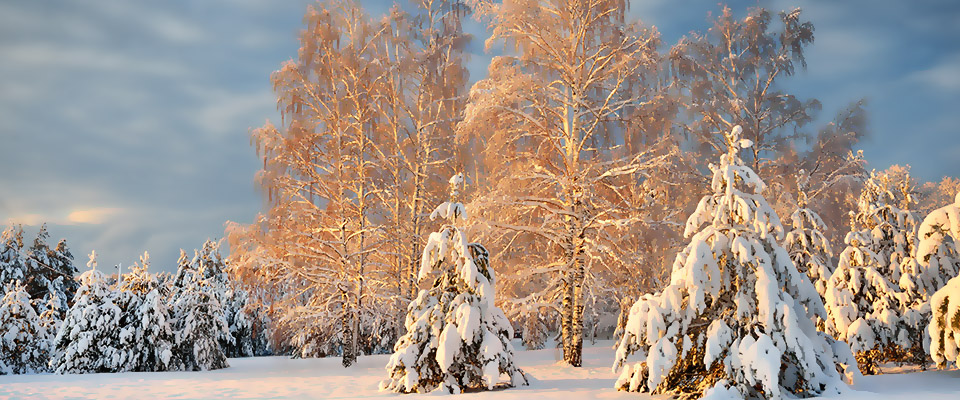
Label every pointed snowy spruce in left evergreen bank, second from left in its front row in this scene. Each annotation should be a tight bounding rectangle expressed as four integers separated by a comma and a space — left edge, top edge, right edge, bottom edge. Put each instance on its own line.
50, 252, 127, 374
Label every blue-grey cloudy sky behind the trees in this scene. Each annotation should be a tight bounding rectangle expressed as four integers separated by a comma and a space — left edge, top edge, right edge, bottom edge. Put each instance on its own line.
0, 0, 960, 271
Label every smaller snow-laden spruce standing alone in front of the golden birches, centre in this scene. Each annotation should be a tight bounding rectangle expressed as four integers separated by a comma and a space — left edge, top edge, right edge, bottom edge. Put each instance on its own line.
380, 174, 527, 393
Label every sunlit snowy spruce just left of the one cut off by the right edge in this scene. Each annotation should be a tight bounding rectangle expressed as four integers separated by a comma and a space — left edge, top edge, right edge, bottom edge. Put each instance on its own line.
824, 169, 929, 374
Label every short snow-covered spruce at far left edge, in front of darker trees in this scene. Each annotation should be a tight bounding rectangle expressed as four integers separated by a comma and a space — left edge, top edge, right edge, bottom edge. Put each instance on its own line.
0, 281, 49, 375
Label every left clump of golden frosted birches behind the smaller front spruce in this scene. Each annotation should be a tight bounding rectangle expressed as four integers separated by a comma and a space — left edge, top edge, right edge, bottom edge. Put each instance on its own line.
228, 0, 469, 366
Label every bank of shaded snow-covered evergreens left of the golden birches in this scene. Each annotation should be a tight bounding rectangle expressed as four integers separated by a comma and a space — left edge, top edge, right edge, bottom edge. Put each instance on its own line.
0, 234, 272, 375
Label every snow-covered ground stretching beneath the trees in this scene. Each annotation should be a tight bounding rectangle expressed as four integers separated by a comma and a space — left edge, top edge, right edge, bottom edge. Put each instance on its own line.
0, 341, 960, 400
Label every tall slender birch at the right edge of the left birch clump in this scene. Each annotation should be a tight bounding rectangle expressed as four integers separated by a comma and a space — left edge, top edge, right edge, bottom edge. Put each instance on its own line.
376, 0, 471, 335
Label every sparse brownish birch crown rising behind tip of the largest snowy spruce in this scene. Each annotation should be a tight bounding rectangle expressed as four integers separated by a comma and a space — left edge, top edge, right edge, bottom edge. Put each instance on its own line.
670, 7, 820, 175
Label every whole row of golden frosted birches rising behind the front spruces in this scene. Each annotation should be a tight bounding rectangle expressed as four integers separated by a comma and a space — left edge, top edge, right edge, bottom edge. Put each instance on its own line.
227, 0, 960, 372
